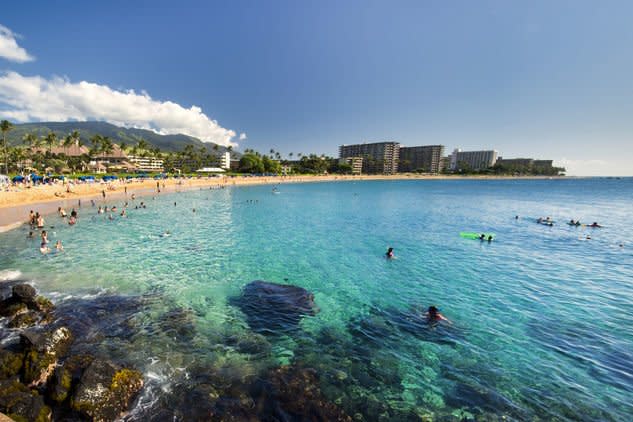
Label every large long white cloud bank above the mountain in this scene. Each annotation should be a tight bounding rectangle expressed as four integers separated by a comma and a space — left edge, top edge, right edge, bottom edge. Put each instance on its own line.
0, 72, 246, 146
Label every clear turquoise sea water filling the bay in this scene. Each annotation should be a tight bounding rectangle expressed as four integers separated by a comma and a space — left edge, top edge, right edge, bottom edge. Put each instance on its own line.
0, 179, 633, 421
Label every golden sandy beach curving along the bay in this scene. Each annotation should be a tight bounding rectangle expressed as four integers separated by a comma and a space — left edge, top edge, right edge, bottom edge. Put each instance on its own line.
0, 174, 571, 233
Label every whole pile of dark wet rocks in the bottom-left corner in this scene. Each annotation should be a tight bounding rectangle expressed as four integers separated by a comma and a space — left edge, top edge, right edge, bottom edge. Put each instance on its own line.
0, 283, 143, 422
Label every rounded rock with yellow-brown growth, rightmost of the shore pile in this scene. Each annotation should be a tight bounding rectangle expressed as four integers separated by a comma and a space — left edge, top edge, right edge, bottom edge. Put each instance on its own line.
70, 360, 143, 421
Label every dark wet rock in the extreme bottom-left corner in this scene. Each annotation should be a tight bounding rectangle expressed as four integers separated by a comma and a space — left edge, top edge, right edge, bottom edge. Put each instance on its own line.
0, 380, 52, 422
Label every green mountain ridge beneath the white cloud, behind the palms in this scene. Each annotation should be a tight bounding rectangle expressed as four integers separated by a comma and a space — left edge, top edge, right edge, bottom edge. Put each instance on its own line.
7, 122, 237, 156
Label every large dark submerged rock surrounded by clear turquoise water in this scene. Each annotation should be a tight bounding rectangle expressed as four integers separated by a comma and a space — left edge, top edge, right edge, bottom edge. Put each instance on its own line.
231, 280, 318, 334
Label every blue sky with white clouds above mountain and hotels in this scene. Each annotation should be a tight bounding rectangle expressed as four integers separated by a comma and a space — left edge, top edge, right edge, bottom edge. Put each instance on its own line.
0, 0, 633, 176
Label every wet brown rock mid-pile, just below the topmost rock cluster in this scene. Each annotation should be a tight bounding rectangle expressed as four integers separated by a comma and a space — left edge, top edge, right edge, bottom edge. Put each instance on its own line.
20, 327, 73, 386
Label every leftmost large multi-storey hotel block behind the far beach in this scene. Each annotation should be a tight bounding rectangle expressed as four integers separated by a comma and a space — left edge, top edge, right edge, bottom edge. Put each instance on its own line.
339, 141, 400, 174
